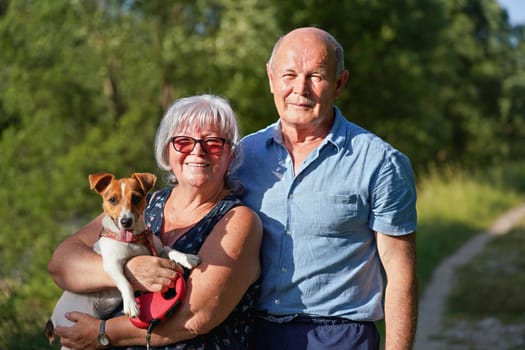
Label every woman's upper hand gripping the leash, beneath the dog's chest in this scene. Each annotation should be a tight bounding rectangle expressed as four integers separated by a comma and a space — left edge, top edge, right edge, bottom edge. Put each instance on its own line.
124, 255, 183, 292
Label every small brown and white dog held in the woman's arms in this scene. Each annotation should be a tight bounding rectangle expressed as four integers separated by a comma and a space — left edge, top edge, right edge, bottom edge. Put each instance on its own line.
45, 173, 200, 342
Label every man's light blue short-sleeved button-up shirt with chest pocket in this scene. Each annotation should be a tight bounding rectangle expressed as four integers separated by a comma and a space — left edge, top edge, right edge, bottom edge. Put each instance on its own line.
235, 107, 416, 321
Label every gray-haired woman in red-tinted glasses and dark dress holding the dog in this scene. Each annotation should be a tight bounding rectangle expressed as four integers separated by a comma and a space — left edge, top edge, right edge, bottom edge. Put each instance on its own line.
48, 95, 262, 349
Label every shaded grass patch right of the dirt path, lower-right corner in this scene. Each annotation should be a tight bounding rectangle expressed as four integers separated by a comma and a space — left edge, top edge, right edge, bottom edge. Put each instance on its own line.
439, 222, 525, 350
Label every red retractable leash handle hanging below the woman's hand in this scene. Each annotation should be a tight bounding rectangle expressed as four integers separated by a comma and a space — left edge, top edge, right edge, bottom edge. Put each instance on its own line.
129, 274, 186, 350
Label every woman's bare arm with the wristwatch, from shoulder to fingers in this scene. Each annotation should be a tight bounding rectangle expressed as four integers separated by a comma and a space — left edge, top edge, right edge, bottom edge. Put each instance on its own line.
57, 207, 262, 349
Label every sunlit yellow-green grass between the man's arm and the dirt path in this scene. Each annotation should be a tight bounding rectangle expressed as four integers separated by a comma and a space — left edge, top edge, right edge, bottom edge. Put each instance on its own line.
417, 165, 525, 291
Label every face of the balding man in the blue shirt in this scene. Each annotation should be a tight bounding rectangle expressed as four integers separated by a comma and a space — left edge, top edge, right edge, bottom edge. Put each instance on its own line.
267, 34, 346, 126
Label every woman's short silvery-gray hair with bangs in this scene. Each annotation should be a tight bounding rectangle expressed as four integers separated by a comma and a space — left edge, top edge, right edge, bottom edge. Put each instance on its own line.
151, 94, 241, 187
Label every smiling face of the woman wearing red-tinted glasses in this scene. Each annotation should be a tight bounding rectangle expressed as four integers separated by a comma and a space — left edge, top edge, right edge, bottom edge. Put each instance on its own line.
167, 127, 232, 187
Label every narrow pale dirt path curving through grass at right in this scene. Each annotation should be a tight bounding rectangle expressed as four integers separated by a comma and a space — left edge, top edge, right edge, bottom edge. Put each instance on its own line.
414, 205, 525, 350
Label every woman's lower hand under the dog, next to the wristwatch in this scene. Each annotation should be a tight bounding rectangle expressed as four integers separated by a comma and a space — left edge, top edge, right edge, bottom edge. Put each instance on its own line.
55, 311, 102, 350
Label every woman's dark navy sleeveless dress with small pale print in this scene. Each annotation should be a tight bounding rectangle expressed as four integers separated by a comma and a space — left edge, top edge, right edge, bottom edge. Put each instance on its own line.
119, 187, 258, 350
